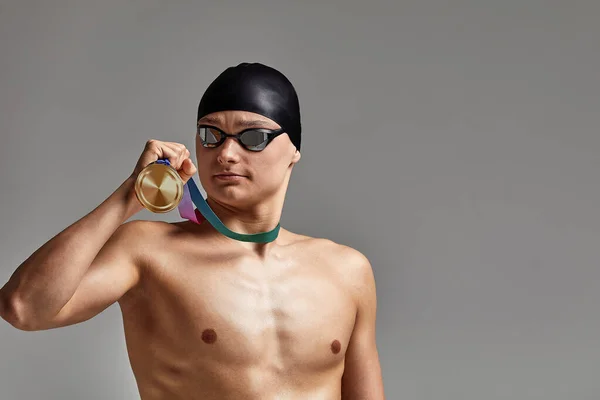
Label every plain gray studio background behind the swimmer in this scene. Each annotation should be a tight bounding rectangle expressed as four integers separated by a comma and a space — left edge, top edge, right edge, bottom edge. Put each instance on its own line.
0, 0, 600, 400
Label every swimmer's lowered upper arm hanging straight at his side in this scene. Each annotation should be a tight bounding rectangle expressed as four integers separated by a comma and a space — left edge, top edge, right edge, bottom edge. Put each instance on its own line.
342, 253, 385, 400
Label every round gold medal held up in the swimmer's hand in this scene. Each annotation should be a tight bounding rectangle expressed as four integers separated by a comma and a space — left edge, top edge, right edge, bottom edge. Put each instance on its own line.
135, 162, 183, 213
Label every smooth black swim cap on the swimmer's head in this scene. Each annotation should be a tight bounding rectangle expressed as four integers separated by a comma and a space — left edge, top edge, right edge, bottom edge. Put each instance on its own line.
196, 63, 302, 150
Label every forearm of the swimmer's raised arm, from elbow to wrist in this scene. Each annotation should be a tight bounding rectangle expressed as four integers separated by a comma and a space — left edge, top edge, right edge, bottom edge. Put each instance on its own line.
0, 177, 142, 323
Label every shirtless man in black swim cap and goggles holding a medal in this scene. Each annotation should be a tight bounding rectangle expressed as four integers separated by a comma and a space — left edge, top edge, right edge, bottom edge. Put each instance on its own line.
0, 64, 384, 400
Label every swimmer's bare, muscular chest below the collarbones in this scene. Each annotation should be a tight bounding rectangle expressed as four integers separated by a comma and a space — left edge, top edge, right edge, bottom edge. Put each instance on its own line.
125, 250, 356, 371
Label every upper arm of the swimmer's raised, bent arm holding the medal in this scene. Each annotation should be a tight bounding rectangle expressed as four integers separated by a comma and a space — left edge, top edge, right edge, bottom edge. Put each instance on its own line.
40, 221, 141, 329
